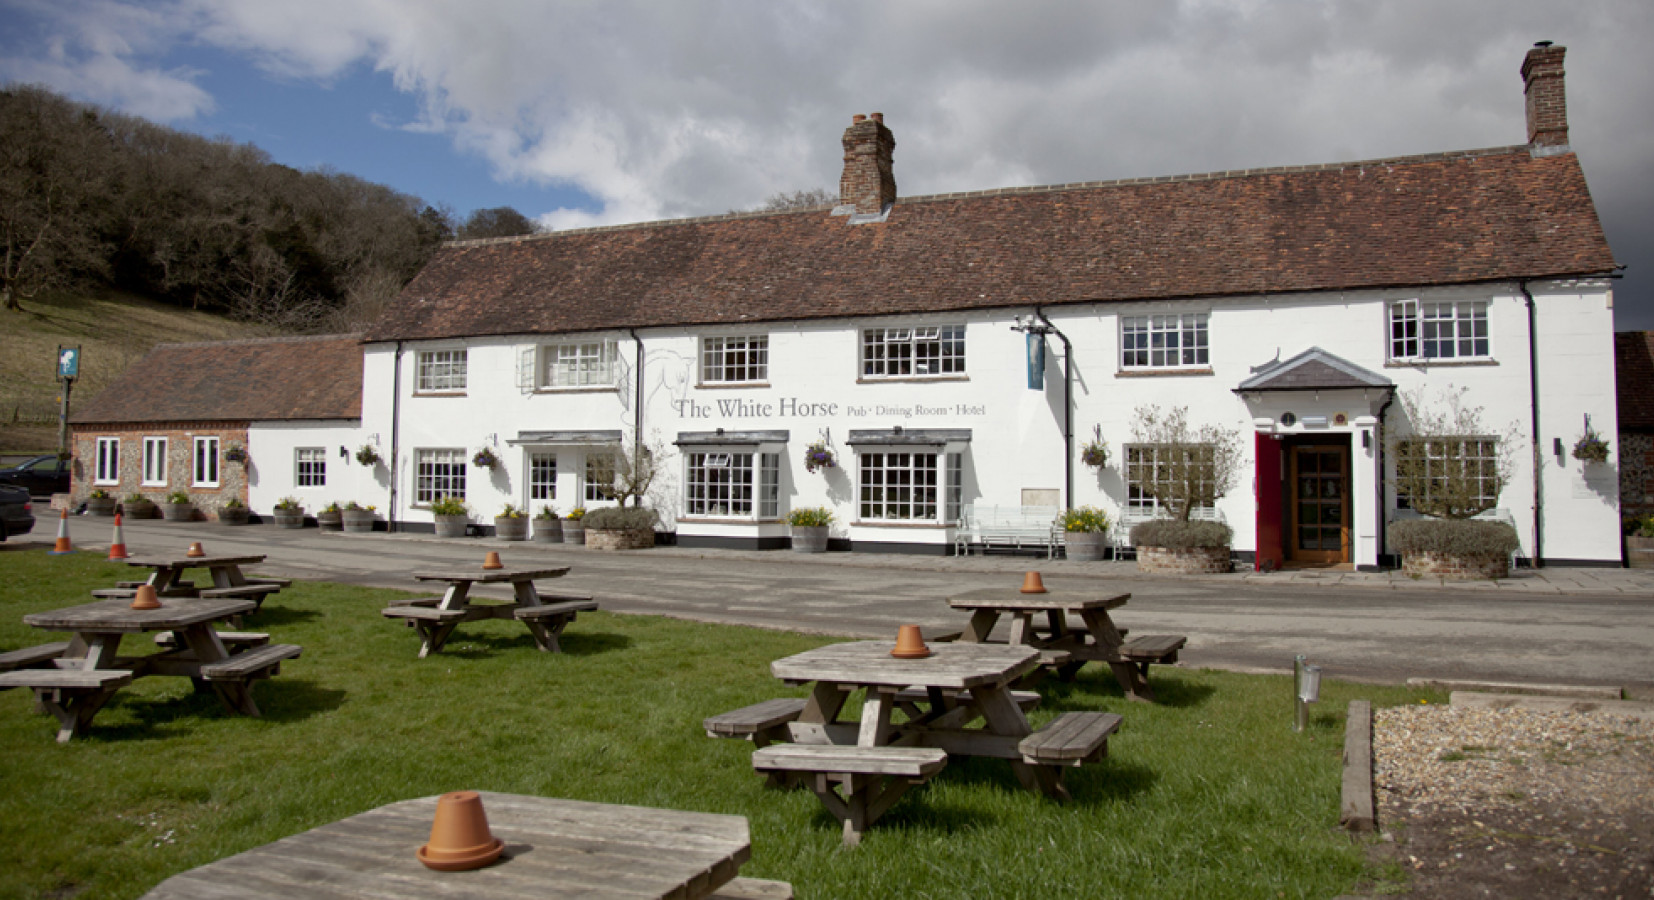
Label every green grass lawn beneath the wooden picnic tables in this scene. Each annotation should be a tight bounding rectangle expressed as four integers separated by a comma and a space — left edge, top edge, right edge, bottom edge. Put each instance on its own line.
0, 549, 1422, 900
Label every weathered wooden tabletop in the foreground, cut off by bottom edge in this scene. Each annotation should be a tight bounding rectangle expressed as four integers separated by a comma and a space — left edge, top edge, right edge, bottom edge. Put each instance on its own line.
144, 792, 792, 900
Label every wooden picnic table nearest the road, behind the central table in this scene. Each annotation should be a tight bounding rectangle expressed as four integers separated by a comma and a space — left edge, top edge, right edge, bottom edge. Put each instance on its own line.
948, 587, 1186, 701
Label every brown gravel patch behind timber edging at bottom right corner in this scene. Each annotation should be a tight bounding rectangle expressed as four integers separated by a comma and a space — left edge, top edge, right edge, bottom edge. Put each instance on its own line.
1373, 705, 1654, 900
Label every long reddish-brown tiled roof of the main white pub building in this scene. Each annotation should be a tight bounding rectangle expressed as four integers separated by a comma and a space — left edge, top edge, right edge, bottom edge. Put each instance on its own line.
367, 147, 1614, 341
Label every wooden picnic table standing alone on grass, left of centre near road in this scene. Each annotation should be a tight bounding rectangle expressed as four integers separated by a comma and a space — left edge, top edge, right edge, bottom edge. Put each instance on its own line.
384, 566, 597, 658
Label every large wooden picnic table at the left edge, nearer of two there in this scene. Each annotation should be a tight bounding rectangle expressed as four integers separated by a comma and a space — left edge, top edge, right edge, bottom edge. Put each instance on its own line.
0, 597, 299, 743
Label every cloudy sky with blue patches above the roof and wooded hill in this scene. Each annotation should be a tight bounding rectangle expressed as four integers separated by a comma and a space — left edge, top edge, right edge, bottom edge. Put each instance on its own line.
0, 0, 1654, 329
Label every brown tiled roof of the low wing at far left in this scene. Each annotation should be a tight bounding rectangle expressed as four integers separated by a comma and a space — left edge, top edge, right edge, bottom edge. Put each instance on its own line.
69, 334, 362, 425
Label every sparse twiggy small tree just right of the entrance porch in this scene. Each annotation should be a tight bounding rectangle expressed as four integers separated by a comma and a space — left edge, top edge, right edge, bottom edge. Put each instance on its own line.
1386, 389, 1522, 519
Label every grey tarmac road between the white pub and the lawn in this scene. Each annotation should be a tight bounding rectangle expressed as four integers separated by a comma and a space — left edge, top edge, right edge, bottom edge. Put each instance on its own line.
32, 511, 1654, 698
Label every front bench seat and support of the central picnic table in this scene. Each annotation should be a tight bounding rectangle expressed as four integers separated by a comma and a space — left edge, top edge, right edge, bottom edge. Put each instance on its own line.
753, 744, 948, 847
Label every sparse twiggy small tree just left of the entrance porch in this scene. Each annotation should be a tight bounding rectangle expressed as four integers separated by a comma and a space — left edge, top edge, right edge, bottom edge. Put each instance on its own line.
1126, 405, 1241, 521
